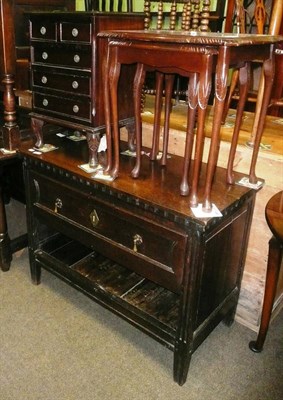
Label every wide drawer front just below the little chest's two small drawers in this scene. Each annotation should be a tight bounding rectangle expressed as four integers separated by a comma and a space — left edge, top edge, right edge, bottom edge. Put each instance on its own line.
32, 43, 92, 71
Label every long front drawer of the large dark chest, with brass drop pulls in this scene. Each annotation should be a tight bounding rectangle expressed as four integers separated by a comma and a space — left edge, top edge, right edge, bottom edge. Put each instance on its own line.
33, 174, 187, 291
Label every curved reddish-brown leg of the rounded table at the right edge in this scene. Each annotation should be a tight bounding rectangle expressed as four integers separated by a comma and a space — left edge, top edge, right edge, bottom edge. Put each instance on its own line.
249, 236, 283, 353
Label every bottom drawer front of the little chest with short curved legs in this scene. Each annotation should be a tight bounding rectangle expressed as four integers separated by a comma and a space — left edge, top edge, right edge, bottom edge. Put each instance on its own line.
33, 92, 92, 122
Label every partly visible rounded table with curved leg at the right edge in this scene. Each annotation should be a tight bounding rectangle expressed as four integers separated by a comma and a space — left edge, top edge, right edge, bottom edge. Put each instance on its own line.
249, 191, 283, 353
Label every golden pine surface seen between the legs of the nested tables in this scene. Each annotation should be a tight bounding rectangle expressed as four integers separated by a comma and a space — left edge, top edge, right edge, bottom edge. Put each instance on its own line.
142, 96, 283, 155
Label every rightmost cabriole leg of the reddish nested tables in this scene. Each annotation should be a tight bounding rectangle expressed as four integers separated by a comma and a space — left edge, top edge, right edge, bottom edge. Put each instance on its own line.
249, 45, 275, 183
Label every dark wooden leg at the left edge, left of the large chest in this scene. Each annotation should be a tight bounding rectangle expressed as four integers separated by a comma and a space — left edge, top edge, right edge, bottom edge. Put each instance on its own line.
0, 181, 12, 271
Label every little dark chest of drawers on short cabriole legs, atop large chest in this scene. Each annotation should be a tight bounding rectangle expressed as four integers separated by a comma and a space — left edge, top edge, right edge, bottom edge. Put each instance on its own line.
30, 12, 143, 165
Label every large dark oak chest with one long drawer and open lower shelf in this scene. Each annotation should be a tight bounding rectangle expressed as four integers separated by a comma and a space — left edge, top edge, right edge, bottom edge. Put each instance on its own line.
20, 137, 255, 385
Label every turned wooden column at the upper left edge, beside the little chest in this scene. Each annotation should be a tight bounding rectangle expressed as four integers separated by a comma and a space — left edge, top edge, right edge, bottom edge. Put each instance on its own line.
0, 0, 20, 150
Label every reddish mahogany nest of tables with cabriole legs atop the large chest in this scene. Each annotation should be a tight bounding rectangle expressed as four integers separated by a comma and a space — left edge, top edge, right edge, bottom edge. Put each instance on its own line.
99, 30, 283, 212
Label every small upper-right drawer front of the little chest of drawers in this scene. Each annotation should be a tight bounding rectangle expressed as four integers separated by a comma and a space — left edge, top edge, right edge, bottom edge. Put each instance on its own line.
60, 22, 91, 43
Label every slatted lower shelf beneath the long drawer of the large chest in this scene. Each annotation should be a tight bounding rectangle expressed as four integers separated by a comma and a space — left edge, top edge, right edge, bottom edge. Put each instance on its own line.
35, 233, 180, 349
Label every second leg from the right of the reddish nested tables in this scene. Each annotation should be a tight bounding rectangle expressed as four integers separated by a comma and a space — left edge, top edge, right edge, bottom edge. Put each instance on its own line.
229, 63, 250, 185
